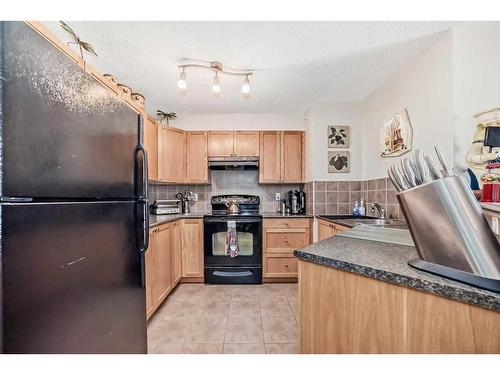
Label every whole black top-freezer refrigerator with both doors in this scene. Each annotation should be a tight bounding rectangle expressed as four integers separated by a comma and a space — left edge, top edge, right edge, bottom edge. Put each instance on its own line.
0, 22, 148, 353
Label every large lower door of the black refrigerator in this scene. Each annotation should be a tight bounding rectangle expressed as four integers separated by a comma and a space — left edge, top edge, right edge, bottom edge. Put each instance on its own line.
1, 202, 146, 353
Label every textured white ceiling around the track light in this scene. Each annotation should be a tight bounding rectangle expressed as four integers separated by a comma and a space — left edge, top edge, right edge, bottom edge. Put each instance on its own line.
45, 21, 451, 113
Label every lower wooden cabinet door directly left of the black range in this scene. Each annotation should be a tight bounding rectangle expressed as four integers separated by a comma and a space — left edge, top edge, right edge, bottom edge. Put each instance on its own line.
182, 219, 204, 279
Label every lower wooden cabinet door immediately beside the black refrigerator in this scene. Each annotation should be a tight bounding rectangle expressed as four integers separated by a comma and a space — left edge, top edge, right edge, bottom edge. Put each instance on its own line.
153, 223, 172, 306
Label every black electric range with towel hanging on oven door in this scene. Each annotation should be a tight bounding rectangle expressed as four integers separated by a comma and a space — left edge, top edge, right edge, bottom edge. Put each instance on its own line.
203, 195, 262, 284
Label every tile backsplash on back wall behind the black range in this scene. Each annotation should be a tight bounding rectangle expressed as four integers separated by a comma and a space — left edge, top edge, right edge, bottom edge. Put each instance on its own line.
149, 170, 304, 212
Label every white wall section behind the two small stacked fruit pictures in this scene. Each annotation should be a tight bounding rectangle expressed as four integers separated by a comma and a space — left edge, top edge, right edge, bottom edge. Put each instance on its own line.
306, 102, 363, 181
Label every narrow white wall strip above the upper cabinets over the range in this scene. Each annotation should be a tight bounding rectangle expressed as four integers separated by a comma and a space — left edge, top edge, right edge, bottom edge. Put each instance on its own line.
172, 113, 305, 130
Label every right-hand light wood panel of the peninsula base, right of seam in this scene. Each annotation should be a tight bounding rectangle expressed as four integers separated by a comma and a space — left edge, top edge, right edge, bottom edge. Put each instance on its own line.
408, 290, 500, 354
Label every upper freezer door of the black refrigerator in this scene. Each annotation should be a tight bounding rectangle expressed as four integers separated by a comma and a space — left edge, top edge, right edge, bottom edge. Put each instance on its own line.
0, 22, 147, 199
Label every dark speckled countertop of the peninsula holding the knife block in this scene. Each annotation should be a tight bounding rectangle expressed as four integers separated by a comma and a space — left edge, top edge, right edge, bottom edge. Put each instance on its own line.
294, 234, 500, 312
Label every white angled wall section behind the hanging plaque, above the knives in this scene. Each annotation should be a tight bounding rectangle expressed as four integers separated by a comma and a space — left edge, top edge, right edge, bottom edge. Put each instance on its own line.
362, 32, 454, 179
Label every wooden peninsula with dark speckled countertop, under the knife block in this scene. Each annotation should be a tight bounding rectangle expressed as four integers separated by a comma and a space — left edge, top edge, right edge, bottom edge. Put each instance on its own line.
294, 234, 500, 354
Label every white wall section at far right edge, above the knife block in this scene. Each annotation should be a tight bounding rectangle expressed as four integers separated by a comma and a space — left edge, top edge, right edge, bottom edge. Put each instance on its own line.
453, 22, 500, 175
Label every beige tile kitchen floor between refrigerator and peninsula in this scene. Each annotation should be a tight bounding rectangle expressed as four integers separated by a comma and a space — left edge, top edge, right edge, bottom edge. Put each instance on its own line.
148, 284, 298, 354
